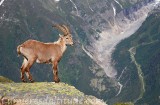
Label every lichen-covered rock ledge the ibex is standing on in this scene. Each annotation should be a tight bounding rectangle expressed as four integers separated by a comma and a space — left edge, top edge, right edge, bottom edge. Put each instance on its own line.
0, 82, 106, 105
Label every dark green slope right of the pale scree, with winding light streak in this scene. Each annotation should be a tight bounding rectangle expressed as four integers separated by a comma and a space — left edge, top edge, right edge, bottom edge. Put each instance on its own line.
113, 6, 160, 105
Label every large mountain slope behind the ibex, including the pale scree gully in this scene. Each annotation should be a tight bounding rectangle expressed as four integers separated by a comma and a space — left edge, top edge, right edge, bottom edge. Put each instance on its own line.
0, 0, 160, 104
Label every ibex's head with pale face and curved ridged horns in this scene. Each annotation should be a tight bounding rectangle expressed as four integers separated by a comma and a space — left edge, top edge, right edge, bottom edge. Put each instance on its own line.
53, 24, 73, 45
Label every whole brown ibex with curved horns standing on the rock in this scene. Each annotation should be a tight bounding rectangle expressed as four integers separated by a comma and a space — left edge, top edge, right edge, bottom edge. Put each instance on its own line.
17, 24, 73, 83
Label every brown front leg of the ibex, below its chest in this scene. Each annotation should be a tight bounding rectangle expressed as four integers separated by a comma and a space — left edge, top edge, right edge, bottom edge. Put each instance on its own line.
53, 62, 60, 83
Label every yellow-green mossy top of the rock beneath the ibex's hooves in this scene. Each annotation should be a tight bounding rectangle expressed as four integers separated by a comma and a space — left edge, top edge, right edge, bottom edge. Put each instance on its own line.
0, 82, 84, 96
